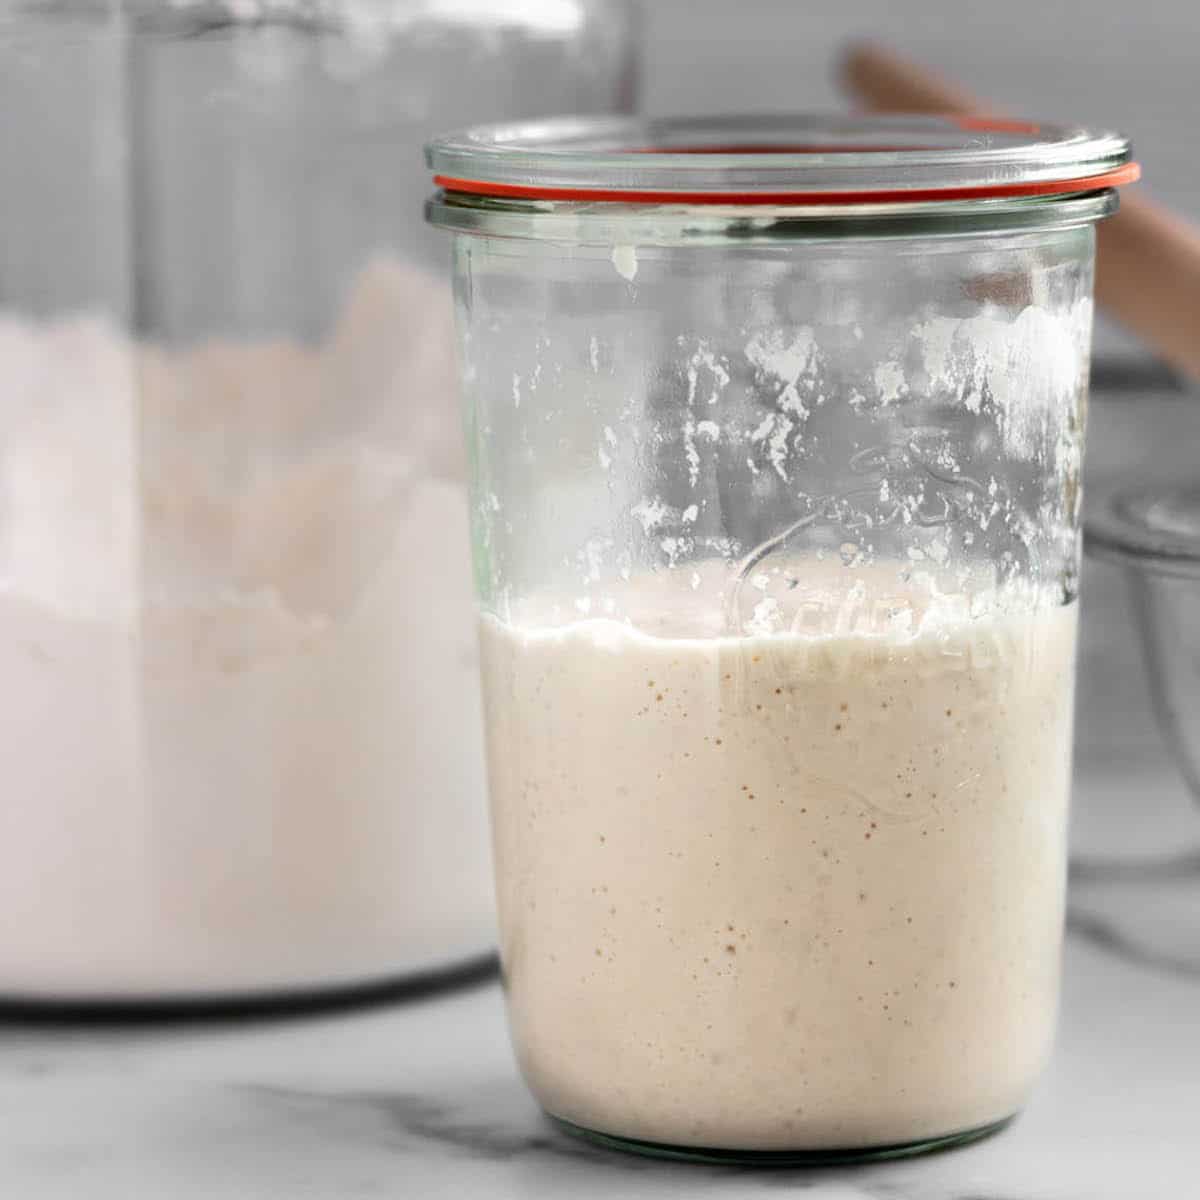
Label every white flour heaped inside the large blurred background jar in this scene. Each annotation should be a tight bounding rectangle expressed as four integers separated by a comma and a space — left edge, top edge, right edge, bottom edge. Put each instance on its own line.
0, 260, 491, 997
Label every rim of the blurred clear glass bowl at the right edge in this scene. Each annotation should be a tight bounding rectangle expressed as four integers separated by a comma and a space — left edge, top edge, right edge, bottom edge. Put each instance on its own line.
1085, 482, 1200, 577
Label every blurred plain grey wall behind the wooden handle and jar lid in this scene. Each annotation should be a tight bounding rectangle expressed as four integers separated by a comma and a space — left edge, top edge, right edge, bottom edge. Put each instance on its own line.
642, 0, 1200, 359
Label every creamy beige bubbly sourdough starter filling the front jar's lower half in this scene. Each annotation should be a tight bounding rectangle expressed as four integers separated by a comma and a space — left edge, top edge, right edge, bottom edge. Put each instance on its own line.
482, 564, 1075, 1150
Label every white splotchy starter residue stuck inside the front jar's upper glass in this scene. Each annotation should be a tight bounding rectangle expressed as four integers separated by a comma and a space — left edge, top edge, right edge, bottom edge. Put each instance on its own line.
559, 300, 1091, 594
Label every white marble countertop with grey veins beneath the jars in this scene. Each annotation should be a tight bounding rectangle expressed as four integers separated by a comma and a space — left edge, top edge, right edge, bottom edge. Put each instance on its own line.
0, 773, 1200, 1200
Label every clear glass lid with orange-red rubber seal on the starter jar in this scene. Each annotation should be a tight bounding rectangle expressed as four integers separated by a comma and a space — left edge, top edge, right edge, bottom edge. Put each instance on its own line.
426, 115, 1140, 206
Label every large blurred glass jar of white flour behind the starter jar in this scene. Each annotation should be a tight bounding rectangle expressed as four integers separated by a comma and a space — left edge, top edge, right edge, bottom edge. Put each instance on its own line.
0, 0, 634, 1002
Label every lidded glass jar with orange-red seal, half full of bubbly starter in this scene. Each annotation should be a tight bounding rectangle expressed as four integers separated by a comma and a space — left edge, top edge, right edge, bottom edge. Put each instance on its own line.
428, 119, 1136, 1160
